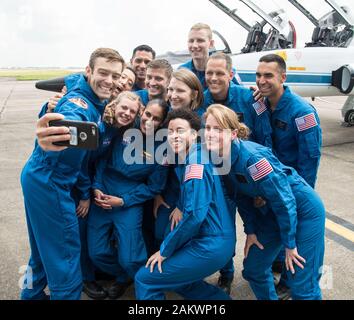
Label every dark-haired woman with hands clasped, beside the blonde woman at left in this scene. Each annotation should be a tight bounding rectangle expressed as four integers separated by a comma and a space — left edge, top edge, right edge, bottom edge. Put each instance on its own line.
88, 100, 168, 298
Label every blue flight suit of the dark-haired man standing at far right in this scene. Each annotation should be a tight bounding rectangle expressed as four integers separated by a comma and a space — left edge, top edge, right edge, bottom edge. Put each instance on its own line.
266, 87, 322, 188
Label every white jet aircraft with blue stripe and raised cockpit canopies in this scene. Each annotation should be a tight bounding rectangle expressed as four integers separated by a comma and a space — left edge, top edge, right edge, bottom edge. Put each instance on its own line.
209, 0, 354, 125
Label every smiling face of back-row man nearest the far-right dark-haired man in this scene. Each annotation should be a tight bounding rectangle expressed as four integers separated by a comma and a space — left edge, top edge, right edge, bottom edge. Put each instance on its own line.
205, 59, 233, 100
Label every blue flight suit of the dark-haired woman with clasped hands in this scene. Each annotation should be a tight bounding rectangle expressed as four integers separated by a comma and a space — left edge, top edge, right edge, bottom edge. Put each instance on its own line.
88, 129, 167, 282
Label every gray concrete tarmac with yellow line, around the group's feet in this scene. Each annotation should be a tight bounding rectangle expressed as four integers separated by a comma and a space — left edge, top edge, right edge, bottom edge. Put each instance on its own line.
0, 78, 354, 300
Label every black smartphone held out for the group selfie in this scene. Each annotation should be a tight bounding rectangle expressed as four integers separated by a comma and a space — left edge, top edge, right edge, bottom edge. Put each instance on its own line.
49, 120, 99, 150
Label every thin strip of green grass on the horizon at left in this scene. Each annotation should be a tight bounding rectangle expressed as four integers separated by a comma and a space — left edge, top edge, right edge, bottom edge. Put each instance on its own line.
0, 69, 83, 81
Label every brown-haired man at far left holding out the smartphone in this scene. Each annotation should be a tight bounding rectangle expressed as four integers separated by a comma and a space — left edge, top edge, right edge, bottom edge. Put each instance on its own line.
21, 48, 124, 300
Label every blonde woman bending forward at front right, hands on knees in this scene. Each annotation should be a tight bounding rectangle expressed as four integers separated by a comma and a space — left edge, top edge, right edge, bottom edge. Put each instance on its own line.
204, 105, 325, 300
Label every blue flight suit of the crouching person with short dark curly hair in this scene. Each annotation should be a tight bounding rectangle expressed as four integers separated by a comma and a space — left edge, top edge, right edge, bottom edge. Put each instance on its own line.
135, 145, 235, 300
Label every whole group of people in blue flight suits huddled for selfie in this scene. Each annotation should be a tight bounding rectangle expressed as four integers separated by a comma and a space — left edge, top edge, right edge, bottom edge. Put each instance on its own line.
21, 20, 325, 299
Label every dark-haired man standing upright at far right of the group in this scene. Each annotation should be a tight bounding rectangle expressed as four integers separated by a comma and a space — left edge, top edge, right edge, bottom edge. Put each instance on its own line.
256, 55, 322, 298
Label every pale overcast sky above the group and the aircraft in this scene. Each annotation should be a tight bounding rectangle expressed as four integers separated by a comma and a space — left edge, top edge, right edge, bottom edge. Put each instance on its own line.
0, 0, 354, 68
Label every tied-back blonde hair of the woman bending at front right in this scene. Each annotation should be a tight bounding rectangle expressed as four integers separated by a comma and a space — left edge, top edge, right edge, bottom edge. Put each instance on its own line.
203, 104, 250, 140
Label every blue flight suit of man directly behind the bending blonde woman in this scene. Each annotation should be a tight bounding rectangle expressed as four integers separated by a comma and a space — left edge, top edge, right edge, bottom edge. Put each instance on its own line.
197, 82, 272, 147
